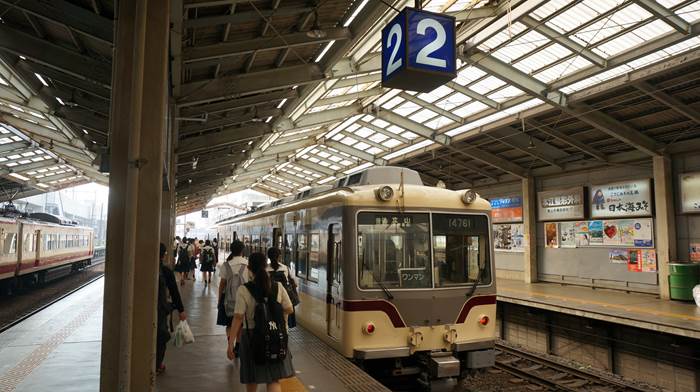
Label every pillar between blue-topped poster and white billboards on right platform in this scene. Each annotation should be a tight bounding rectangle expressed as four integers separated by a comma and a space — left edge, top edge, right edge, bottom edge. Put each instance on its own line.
522, 177, 537, 283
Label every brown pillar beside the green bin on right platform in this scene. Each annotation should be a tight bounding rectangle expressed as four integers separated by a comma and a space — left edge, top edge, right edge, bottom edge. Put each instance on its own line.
653, 156, 677, 299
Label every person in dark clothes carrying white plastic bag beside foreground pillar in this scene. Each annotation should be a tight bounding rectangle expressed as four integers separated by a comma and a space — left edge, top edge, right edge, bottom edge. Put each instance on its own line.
156, 242, 187, 374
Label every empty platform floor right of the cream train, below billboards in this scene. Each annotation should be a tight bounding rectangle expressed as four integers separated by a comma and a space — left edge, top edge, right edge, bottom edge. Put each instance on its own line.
497, 279, 700, 339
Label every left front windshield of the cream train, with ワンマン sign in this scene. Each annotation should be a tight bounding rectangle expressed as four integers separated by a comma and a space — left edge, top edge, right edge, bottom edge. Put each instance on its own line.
357, 212, 433, 289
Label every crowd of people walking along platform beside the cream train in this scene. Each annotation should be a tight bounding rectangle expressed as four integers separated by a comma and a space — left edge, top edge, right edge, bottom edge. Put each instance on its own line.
156, 236, 299, 392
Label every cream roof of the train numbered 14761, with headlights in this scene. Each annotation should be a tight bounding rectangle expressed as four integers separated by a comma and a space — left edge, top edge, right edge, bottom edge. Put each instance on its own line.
217, 166, 491, 225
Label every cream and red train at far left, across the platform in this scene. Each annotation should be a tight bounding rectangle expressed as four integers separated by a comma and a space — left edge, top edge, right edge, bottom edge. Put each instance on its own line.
0, 204, 95, 291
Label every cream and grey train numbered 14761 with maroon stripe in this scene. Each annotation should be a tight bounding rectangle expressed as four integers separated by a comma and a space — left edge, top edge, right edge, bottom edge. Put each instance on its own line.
217, 167, 496, 388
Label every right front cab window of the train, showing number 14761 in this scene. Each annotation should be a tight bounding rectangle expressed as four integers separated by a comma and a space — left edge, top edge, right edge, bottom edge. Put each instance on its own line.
433, 214, 491, 287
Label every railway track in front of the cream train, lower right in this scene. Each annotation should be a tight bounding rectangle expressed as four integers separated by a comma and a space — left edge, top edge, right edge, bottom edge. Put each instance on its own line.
495, 342, 658, 392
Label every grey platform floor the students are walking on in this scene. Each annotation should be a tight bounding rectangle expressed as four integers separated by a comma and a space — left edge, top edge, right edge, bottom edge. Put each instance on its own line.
0, 270, 388, 392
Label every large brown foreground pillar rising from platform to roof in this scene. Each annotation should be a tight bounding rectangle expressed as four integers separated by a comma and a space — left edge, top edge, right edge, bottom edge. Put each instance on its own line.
100, 0, 170, 392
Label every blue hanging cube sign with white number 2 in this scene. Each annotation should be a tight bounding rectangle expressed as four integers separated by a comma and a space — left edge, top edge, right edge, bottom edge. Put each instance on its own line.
382, 7, 456, 92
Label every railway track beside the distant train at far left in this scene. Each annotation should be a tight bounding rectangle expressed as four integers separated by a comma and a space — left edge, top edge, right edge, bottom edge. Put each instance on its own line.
0, 257, 104, 333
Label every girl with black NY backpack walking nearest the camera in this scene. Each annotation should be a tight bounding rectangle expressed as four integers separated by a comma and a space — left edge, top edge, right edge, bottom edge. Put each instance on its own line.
227, 252, 294, 392
